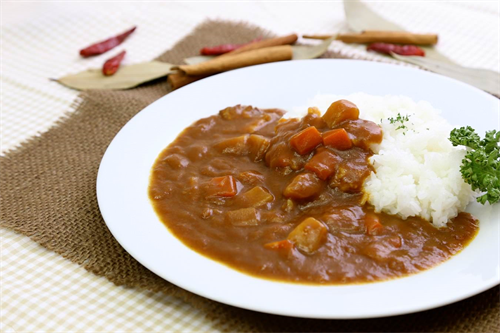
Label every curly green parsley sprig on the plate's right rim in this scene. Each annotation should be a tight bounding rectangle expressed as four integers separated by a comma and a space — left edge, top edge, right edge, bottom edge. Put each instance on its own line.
449, 126, 500, 205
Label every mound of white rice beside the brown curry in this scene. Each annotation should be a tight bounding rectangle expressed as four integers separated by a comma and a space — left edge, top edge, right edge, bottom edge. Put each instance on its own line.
287, 93, 474, 227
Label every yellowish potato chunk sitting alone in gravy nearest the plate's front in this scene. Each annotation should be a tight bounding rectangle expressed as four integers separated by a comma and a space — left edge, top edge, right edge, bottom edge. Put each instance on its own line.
287, 217, 328, 254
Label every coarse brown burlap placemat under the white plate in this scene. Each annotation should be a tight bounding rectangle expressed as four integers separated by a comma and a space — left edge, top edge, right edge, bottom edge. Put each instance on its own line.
0, 21, 500, 332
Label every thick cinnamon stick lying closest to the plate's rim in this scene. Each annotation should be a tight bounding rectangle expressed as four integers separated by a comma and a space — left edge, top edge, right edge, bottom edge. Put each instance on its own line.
176, 45, 293, 76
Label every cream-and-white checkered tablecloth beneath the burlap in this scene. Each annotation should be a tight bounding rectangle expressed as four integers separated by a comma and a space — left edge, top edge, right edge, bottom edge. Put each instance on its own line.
0, 1, 500, 332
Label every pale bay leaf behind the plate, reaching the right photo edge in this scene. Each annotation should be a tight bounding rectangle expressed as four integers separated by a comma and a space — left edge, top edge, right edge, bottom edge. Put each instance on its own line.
391, 53, 500, 96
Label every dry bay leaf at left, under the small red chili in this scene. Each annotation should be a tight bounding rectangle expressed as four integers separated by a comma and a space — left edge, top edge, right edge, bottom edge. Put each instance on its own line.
55, 61, 175, 90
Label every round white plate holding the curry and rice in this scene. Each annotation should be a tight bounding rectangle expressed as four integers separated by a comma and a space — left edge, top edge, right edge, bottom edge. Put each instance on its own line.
97, 59, 500, 319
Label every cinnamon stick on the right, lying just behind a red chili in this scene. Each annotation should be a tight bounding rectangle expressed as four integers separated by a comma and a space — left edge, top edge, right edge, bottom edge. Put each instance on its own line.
303, 30, 438, 45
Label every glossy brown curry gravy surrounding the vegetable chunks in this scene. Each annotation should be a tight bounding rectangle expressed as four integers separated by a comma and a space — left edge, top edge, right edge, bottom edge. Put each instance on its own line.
149, 105, 478, 284
